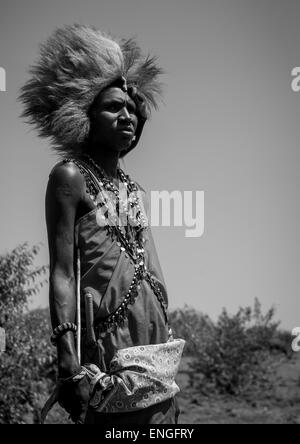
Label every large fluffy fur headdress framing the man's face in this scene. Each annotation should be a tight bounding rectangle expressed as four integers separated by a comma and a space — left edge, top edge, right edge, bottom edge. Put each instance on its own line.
19, 25, 162, 155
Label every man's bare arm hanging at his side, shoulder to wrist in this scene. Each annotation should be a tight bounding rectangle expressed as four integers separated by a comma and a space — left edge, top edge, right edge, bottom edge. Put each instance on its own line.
46, 164, 84, 377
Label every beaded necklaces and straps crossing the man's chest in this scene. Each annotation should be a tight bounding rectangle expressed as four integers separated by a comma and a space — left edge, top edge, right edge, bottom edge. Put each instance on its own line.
64, 156, 169, 334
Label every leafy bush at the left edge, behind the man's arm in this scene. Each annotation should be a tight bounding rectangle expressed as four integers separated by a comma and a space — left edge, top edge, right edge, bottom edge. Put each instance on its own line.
0, 243, 54, 424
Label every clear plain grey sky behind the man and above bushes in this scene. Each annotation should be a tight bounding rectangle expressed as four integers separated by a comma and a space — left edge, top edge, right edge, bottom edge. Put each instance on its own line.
0, 0, 300, 329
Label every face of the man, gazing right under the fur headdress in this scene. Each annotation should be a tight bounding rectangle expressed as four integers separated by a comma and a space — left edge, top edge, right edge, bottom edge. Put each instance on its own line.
90, 87, 138, 152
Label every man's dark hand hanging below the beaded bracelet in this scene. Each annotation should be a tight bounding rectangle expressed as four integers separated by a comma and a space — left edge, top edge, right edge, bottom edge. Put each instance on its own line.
58, 376, 90, 424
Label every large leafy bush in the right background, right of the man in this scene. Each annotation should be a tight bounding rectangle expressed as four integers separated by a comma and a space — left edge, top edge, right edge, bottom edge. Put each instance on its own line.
172, 300, 286, 395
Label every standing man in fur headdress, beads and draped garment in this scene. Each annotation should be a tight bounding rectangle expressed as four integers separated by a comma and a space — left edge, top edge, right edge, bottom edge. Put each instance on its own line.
21, 25, 182, 424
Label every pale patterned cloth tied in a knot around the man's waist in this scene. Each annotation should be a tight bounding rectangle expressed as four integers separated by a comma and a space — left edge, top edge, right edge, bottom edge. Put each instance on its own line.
85, 339, 185, 413
